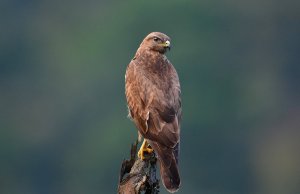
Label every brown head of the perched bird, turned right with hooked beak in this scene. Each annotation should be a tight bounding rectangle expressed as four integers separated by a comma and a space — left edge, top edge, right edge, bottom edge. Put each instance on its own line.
140, 32, 171, 54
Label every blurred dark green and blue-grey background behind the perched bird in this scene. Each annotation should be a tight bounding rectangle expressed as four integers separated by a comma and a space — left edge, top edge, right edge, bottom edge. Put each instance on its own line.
0, 0, 300, 194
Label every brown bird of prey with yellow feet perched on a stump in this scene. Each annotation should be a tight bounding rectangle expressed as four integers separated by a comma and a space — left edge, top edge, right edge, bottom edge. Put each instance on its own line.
125, 32, 181, 193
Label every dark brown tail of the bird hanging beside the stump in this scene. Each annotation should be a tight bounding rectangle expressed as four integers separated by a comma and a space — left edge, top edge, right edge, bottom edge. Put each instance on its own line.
151, 143, 180, 193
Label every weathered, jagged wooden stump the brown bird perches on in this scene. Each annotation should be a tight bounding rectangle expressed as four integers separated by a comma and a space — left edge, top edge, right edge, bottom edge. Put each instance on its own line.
118, 141, 159, 194
